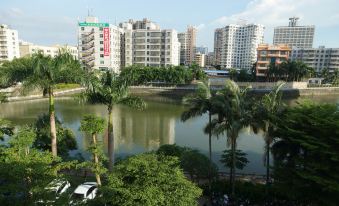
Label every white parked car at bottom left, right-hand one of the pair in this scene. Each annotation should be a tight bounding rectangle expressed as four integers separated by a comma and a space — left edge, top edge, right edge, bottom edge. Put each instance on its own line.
71, 182, 98, 204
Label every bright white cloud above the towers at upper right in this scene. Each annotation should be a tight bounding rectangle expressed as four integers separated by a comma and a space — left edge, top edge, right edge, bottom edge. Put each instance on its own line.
212, 0, 339, 27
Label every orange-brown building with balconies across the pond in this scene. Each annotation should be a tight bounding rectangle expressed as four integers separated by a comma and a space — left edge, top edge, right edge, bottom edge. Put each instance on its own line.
256, 44, 292, 77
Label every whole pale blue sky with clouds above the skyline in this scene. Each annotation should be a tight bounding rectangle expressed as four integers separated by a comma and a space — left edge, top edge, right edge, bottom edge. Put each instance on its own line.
0, 0, 339, 51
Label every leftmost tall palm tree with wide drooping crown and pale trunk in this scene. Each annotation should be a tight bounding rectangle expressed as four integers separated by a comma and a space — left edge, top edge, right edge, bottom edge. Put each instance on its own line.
2, 50, 83, 156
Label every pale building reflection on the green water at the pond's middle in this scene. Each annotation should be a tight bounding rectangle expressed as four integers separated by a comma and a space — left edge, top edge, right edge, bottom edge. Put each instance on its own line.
109, 107, 175, 151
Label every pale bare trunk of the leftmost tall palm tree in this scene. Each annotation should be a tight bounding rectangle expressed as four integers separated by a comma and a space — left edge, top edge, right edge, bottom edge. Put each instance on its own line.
48, 87, 58, 157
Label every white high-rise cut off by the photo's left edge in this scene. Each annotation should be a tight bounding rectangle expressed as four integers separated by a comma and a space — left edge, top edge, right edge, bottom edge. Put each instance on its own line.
0, 24, 20, 61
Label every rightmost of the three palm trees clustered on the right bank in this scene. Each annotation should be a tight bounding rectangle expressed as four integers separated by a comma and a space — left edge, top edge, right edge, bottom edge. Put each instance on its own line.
251, 83, 285, 191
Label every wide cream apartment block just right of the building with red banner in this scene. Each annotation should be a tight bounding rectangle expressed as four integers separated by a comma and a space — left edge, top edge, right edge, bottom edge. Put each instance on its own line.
120, 19, 180, 67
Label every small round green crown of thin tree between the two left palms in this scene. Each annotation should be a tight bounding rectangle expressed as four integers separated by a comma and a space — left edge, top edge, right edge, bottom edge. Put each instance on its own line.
80, 115, 105, 134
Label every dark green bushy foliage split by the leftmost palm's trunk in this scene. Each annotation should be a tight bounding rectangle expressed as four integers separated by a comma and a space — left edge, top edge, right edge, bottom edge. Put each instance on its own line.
33, 114, 77, 159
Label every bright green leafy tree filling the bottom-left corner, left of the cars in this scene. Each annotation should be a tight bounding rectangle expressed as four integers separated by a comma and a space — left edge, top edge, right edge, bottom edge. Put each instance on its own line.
0, 126, 65, 205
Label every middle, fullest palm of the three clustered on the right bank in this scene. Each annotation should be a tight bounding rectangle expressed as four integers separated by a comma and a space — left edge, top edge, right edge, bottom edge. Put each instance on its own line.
209, 80, 250, 196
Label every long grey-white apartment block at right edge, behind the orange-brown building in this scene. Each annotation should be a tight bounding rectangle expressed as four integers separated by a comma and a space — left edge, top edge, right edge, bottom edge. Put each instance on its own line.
291, 46, 339, 72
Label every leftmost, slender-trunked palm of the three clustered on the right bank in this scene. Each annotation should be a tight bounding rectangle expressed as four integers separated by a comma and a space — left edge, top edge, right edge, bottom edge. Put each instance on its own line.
181, 82, 215, 192
